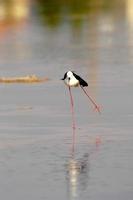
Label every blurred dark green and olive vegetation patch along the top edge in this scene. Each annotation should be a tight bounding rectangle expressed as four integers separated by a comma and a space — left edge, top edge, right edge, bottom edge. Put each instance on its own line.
36, 0, 125, 27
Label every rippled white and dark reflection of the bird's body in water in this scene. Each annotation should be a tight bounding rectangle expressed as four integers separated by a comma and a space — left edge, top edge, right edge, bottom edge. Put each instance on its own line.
66, 135, 99, 200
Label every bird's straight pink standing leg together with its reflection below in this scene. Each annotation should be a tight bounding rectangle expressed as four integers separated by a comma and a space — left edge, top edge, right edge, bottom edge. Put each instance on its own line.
69, 86, 76, 153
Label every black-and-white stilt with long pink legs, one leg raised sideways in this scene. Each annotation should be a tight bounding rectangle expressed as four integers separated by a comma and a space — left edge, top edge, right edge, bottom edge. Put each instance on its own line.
61, 71, 100, 122
